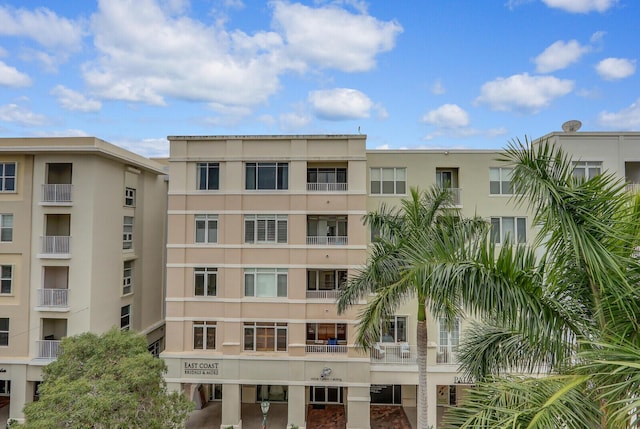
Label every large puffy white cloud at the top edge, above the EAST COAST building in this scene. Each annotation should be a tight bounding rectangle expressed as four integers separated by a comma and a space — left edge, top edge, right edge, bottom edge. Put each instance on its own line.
271, 1, 402, 72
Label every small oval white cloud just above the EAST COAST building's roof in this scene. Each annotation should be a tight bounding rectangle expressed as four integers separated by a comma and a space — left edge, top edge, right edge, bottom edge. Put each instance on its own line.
308, 88, 373, 121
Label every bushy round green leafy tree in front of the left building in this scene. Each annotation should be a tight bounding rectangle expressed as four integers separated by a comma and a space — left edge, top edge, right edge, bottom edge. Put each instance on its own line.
24, 328, 193, 429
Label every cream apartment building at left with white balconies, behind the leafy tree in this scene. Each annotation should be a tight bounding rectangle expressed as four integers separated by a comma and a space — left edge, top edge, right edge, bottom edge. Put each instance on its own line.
0, 137, 167, 420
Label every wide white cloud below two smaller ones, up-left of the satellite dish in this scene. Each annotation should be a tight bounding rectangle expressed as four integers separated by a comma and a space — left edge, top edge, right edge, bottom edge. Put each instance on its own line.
476, 73, 574, 113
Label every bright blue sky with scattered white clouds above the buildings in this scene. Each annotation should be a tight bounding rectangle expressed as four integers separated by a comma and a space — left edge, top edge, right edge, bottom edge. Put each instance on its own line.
0, 0, 640, 157
